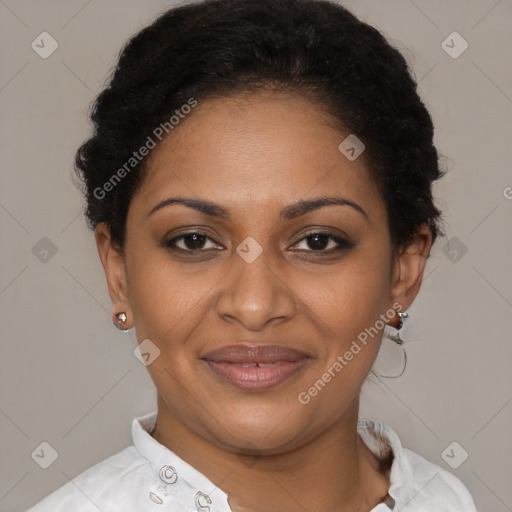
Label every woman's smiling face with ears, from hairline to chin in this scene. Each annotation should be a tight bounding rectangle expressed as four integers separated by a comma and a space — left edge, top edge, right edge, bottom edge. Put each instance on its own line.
97, 93, 429, 453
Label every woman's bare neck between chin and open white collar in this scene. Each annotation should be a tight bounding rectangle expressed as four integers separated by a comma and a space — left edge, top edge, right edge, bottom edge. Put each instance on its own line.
152, 396, 389, 512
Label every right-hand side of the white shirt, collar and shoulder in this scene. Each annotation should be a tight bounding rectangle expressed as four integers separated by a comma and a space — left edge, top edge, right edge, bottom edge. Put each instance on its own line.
358, 418, 476, 512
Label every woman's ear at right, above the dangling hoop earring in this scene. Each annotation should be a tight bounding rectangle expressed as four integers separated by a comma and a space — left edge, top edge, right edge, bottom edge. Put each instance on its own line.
390, 224, 432, 311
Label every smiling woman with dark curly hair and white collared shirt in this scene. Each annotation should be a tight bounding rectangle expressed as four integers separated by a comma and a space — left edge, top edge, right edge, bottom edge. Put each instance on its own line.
27, 0, 475, 512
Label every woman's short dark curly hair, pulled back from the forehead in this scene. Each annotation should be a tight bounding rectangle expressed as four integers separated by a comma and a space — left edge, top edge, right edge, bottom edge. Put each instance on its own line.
75, 0, 443, 249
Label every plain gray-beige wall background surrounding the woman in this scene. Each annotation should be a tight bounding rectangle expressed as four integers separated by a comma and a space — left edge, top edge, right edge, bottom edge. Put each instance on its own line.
0, 0, 512, 512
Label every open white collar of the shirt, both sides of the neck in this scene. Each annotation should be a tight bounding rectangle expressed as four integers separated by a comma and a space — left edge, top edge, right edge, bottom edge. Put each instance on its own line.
132, 411, 412, 512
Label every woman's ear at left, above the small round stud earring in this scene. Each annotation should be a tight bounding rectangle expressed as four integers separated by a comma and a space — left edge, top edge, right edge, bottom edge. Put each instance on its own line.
94, 222, 132, 329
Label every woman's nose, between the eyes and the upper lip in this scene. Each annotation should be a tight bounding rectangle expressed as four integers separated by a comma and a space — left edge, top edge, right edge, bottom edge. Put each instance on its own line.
216, 245, 297, 331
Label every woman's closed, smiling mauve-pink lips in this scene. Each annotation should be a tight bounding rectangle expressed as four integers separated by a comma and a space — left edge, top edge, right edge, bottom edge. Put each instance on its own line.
201, 344, 311, 391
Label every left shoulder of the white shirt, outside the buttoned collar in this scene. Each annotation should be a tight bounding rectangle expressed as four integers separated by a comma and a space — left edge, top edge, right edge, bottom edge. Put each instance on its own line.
27, 445, 152, 512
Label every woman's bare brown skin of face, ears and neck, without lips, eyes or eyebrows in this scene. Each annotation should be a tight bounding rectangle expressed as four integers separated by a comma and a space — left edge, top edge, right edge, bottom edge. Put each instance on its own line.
95, 92, 432, 512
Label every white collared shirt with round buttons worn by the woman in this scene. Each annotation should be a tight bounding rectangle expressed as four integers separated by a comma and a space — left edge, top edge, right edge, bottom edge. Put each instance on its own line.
27, 412, 476, 512
